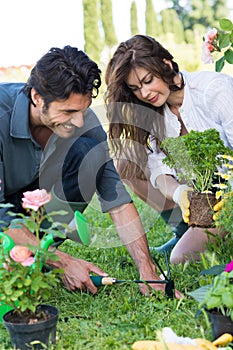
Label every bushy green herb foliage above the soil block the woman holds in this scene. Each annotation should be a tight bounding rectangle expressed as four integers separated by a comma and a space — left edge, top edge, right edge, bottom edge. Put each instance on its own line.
161, 129, 232, 192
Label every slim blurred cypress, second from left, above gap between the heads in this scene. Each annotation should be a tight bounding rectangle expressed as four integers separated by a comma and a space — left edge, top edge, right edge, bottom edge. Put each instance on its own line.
100, 0, 117, 47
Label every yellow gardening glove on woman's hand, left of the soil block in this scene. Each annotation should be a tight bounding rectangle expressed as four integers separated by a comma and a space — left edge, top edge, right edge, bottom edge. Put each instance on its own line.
173, 185, 193, 224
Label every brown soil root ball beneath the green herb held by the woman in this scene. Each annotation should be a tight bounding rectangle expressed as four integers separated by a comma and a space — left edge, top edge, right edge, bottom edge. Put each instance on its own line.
189, 192, 217, 228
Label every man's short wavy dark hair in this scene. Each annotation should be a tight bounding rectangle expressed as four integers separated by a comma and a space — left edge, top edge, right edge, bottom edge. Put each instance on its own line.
23, 46, 101, 108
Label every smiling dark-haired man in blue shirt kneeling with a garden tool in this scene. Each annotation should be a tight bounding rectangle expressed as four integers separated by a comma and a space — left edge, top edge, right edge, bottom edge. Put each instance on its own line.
0, 46, 180, 297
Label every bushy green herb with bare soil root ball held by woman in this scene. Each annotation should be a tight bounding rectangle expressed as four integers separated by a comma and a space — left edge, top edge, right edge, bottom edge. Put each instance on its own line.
161, 129, 232, 227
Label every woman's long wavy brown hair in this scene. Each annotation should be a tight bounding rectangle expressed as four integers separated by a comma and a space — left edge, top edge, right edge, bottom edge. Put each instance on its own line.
105, 35, 183, 178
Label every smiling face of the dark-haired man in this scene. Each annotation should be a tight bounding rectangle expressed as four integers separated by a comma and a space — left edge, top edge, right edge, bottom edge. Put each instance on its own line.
39, 93, 92, 138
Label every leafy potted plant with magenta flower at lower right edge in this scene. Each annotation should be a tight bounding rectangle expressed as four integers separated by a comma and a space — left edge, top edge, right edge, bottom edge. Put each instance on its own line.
189, 260, 233, 338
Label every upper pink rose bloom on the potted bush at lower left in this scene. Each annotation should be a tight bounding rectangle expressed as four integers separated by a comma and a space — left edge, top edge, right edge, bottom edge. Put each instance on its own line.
22, 190, 52, 211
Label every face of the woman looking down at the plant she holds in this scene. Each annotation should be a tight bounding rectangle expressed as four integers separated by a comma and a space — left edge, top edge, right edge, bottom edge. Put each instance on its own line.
126, 67, 170, 107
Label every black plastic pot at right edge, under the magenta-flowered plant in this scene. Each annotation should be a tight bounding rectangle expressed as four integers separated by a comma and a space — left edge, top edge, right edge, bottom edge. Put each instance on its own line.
207, 309, 233, 339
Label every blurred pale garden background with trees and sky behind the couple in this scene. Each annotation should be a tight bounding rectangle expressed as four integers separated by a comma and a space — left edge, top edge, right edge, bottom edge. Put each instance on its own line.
0, 0, 233, 84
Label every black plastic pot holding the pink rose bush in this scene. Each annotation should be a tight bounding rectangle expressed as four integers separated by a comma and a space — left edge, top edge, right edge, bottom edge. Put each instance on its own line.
3, 305, 59, 350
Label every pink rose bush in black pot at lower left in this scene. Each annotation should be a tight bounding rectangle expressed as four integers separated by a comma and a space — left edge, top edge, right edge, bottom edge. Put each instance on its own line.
0, 190, 64, 349
